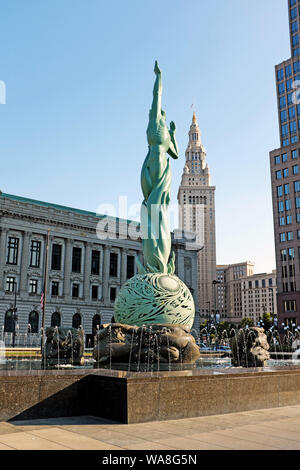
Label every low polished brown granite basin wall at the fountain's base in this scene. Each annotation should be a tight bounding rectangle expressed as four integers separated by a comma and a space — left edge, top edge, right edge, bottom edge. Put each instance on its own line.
0, 365, 300, 423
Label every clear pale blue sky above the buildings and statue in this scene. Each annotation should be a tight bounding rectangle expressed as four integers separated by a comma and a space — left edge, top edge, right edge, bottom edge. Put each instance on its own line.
0, 0, 290, 273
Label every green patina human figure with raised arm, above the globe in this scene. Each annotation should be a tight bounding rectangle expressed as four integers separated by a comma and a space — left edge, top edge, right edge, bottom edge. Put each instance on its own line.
138, 62, 178, 274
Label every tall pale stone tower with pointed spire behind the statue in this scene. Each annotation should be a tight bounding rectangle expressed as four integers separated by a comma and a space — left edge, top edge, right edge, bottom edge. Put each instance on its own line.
177, 113, 216, 318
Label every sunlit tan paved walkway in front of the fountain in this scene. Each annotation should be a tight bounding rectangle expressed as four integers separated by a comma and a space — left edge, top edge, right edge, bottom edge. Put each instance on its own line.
0, 405, 300, 450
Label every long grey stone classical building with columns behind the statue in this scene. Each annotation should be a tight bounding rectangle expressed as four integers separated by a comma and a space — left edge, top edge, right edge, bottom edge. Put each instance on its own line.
0, 189, 199, 339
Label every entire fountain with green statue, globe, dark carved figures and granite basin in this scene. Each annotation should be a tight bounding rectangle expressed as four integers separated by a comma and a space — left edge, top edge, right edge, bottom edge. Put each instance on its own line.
0, 63, 300, 423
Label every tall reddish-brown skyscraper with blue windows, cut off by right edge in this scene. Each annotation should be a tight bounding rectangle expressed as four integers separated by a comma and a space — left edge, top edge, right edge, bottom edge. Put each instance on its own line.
270, 0, 300, 328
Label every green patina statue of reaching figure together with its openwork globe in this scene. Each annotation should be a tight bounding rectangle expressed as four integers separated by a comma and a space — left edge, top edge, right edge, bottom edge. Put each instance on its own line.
115, 62, 195, 328
